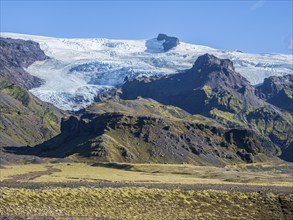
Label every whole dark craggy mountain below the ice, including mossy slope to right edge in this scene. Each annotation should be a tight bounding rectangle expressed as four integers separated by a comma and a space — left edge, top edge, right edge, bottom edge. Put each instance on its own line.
121, 54, 293, 160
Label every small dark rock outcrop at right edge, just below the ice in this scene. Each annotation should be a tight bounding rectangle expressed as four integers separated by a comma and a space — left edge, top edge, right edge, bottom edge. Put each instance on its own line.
256, 74, 293, 113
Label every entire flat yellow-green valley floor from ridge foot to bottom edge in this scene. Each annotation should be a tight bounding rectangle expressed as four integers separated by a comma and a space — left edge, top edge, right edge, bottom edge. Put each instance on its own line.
0, 163, 293, 220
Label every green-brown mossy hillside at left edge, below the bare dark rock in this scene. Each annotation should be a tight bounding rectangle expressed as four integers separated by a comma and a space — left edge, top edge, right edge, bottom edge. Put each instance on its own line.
0, 81, 65, 146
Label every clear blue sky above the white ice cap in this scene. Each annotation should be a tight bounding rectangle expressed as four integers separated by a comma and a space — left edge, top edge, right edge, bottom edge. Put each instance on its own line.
1, 0, 293, 53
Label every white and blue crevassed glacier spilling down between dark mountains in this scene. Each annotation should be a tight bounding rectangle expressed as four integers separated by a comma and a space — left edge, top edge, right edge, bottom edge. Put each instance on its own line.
1, 33, 293, 110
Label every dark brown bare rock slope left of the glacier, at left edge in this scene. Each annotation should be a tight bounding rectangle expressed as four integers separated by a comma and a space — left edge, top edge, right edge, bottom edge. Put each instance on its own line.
0, 37, 48, 89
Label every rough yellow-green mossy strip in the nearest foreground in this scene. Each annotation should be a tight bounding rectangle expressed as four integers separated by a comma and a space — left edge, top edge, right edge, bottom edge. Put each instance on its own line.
0, 188, 293, 220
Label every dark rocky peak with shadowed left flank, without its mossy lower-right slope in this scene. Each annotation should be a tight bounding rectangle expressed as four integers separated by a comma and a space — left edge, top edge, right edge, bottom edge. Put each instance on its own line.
122, 54, 263, 115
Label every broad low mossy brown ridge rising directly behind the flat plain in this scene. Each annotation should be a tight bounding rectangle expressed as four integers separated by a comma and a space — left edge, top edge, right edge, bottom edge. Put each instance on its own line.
6, 99, 279, 165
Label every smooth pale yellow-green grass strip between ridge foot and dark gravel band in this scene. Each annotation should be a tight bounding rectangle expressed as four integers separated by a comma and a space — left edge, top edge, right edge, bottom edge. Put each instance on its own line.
0, 163, 293, 186
